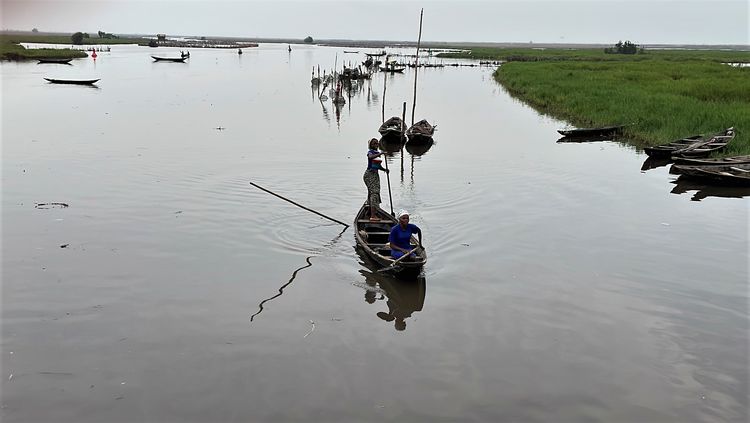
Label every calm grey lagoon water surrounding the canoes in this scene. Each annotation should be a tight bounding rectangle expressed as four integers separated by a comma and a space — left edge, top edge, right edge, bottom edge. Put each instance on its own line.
0, 44, 750, 423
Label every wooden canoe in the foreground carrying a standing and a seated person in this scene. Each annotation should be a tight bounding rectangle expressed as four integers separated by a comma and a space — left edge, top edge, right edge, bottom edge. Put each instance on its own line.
354, 203, 427, 277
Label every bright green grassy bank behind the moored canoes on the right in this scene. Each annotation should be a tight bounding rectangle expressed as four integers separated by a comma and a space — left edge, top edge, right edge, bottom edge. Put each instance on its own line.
494, 61, 750, 155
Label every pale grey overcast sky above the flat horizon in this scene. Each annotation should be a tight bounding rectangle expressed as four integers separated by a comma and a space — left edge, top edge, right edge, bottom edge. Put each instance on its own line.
1, 0, 750, 44
